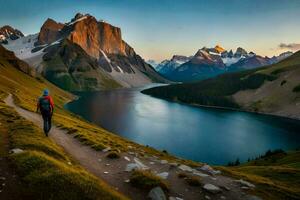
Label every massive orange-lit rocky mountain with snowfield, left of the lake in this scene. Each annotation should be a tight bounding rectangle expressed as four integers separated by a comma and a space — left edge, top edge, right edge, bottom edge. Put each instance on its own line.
0, 13, 167, 91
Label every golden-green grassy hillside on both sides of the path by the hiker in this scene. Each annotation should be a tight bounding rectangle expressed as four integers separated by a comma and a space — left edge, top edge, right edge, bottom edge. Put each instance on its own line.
0, 47, 199, 199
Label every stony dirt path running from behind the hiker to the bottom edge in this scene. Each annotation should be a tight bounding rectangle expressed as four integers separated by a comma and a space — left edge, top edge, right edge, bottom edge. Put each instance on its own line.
5, 95, 260, 200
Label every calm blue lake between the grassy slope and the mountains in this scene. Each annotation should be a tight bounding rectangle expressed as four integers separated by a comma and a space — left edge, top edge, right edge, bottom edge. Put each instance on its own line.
66, 85, 300, 165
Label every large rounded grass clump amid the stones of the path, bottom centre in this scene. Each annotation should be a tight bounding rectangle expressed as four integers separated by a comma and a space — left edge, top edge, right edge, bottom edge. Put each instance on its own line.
130, 170, 169, 190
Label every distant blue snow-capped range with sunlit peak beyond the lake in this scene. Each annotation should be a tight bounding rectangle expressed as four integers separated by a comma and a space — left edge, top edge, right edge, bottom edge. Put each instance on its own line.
150, 45, 293, 82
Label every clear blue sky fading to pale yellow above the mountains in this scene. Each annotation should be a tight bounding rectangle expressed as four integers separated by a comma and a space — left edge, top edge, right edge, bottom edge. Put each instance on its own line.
0, 0, 300, 61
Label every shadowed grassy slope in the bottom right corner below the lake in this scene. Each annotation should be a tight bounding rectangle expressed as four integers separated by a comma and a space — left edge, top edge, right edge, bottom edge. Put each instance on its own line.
219, 151, 300, 200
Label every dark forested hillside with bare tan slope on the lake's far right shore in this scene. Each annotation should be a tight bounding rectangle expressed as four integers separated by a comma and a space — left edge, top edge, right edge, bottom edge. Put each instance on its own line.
143, 51, 300, 119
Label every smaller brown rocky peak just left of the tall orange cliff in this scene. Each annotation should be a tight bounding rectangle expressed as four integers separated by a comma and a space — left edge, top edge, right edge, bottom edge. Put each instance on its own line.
37, 18, 65, 45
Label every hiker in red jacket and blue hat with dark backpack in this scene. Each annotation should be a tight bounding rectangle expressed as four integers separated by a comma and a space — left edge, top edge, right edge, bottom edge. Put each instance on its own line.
36, 89, 54, 137
